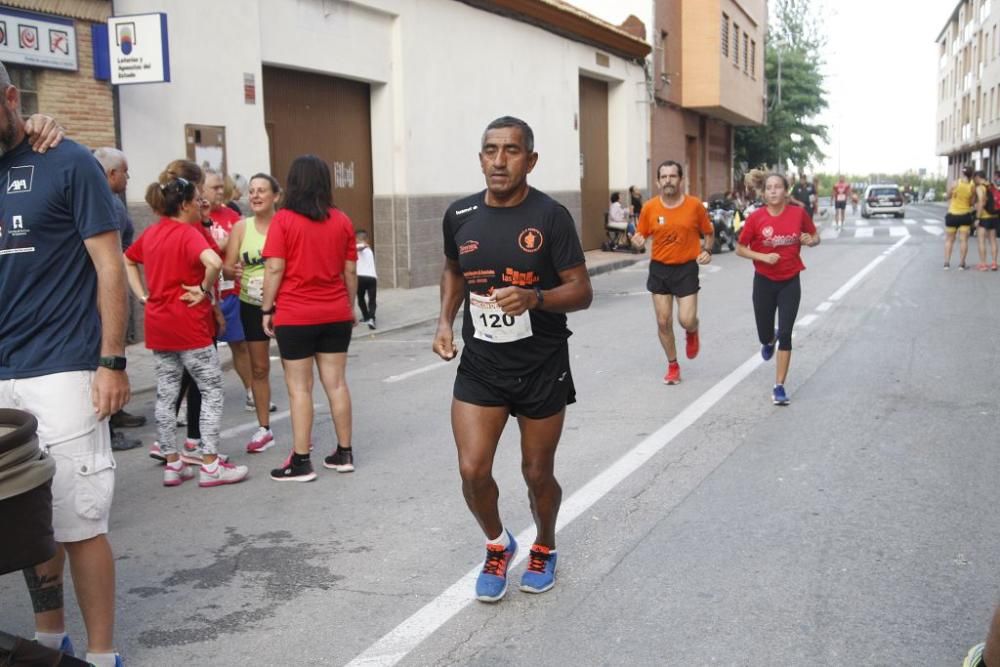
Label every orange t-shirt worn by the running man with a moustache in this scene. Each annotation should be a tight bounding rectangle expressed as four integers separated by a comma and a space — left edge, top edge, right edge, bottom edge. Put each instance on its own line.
636, 195, 713, 264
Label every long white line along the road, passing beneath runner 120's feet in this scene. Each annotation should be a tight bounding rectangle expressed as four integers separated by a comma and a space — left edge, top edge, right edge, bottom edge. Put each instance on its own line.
347, 232, 909, 667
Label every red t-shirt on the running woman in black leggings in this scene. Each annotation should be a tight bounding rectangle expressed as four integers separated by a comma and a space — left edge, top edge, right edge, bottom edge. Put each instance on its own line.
740, 206, 816, 280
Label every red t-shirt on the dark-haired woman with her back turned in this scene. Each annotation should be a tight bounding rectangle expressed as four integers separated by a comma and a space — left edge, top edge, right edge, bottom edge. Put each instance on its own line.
261, 208, 358, 326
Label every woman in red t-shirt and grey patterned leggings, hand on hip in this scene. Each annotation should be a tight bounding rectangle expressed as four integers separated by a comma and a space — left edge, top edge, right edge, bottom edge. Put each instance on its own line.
125, 160, 248, 487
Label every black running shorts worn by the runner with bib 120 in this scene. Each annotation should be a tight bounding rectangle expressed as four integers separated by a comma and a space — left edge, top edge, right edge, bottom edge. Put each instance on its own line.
453, 343, 576, 419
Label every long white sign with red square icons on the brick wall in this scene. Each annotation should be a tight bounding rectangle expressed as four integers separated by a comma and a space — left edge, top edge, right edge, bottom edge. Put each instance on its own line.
0, 8, 77, 72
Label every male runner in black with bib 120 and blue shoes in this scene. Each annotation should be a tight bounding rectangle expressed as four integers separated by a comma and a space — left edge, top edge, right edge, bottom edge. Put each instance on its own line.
433, 116, 593, 602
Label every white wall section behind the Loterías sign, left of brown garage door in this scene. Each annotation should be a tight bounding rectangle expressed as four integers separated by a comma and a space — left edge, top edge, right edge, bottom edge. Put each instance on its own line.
114, 0, 270, 201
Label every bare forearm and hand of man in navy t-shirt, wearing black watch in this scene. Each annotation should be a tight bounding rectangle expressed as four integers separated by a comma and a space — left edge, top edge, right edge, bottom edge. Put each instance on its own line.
83, 231, 130, 419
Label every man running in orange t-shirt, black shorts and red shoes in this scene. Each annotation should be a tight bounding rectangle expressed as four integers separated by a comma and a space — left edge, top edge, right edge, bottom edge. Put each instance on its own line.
632, 160, 714, 384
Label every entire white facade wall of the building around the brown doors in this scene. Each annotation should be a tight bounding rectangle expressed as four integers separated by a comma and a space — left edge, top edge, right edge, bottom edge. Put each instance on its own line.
115, 0, 649, 200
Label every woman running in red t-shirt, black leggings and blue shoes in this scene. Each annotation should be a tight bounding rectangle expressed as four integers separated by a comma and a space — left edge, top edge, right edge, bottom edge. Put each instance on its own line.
736, 174, 819, 405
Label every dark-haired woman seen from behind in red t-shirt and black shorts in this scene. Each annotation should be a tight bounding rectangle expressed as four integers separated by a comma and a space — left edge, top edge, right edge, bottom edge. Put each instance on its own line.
261, 155, 358, 482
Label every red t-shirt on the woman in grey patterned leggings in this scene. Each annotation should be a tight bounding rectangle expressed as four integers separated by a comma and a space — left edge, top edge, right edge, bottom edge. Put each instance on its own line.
125, 218, 215, 352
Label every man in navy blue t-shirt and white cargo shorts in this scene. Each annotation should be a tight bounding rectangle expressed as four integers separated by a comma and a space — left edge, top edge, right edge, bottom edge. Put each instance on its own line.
0, 64, 129, 667
